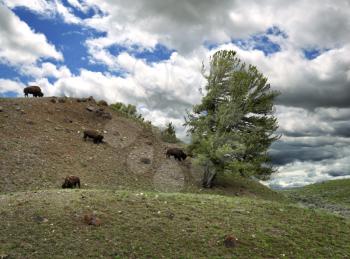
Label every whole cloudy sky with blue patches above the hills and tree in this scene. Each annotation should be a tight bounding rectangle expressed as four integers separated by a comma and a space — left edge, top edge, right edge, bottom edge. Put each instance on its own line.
0, 0, 350, 188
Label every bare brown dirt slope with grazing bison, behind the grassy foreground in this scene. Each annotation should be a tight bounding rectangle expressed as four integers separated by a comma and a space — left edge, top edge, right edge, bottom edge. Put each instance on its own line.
0, 97, 200, 192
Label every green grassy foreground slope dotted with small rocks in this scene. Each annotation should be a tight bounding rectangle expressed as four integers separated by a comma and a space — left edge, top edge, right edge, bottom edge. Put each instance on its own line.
0, 190, 350, 258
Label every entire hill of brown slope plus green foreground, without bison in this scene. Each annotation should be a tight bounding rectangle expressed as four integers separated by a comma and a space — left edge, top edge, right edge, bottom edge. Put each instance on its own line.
0, 97, 350, 258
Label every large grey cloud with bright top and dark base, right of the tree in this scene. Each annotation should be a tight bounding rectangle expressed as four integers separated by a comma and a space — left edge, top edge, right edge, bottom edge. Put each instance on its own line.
275, 46, 350, 110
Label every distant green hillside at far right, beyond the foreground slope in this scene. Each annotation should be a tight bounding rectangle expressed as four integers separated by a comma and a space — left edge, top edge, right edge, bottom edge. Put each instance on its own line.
282, 179, 350, 217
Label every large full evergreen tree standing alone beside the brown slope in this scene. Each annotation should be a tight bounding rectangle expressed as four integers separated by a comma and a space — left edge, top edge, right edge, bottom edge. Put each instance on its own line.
185, 50, 279, 187
